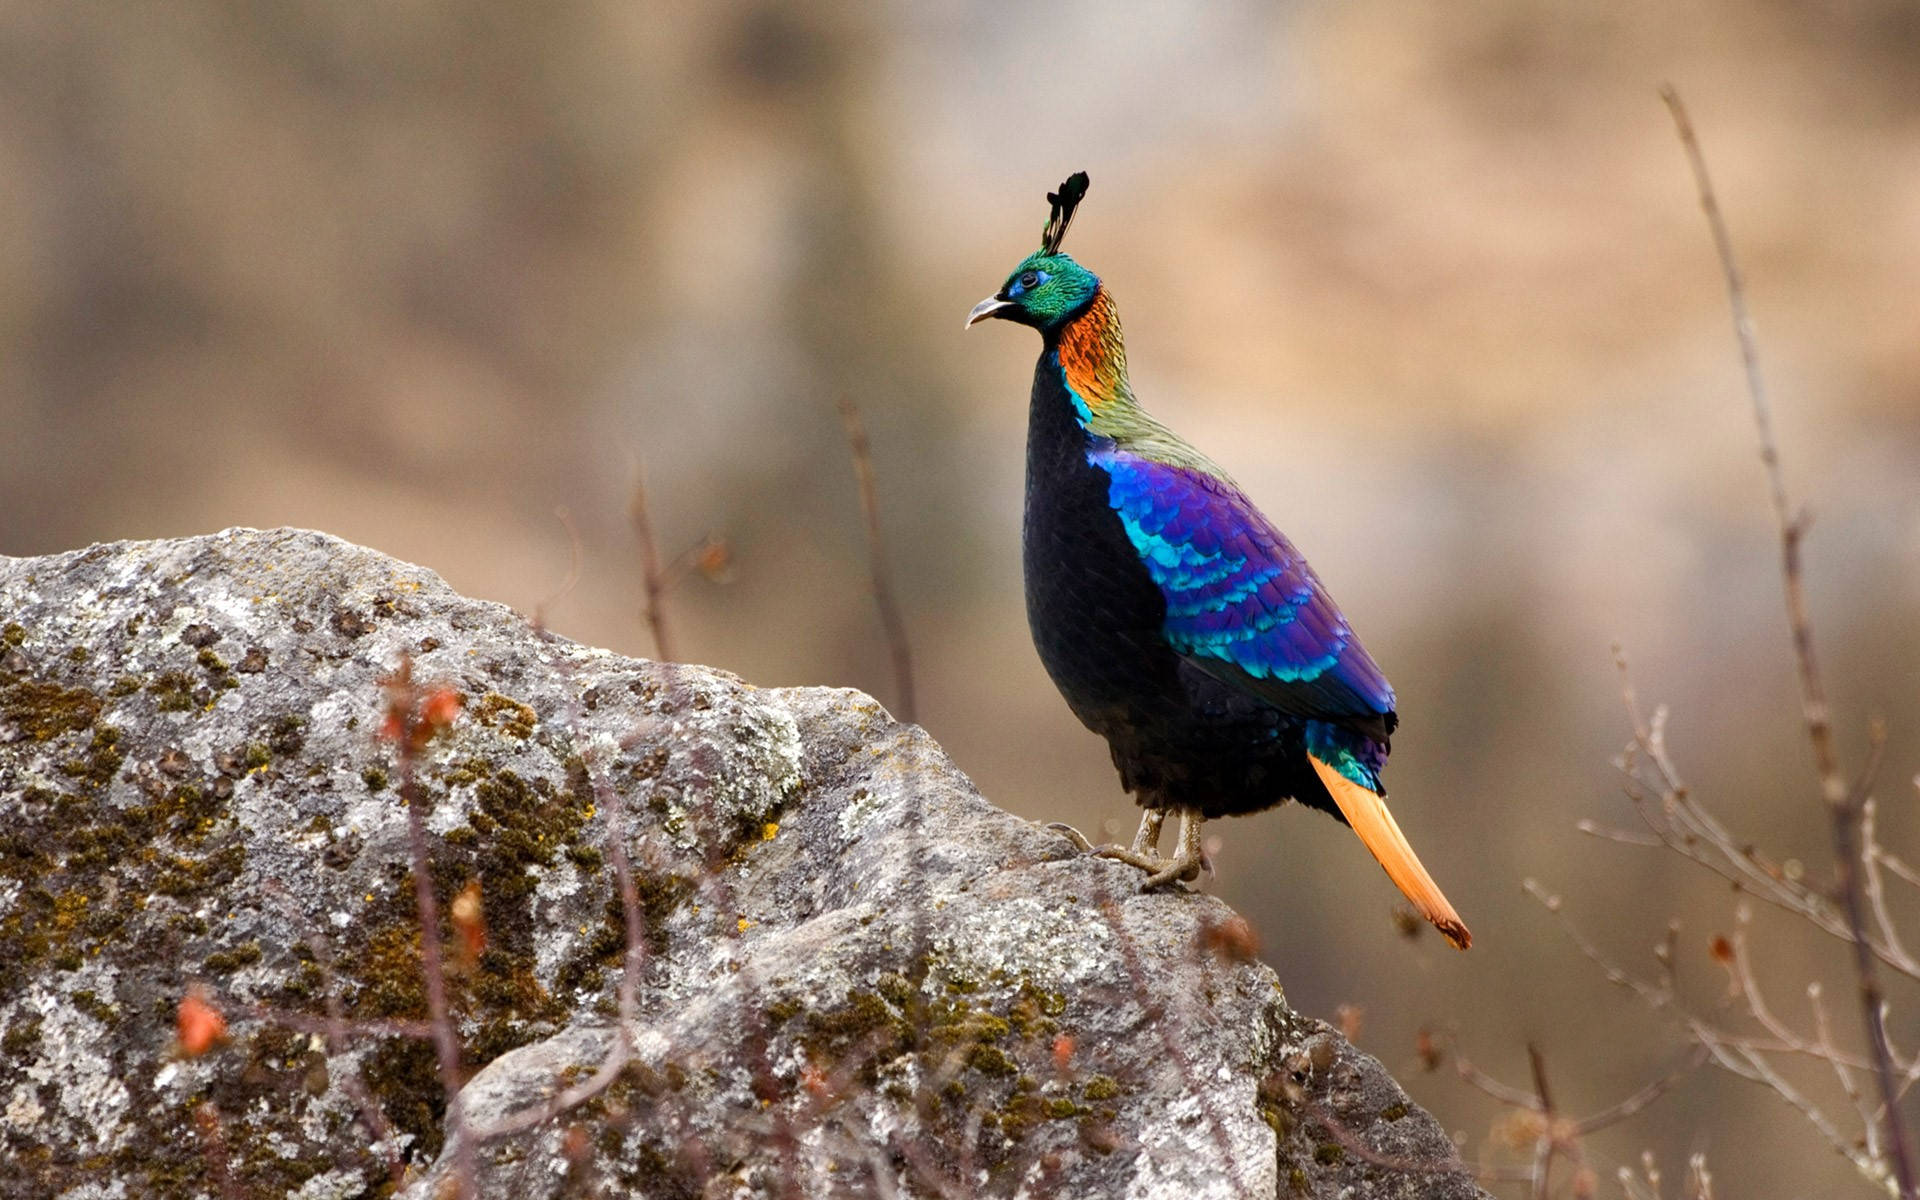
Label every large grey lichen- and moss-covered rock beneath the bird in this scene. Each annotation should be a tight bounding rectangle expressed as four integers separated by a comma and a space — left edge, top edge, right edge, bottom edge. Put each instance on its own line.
0, 530, 1482, 1200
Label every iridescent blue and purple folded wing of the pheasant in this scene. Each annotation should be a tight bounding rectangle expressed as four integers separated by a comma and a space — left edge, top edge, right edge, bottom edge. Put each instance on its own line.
1089, 447, 1394, 743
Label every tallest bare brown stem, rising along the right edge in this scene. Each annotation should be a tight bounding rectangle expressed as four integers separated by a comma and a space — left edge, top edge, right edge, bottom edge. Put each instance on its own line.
1661, 86, 1920, 1200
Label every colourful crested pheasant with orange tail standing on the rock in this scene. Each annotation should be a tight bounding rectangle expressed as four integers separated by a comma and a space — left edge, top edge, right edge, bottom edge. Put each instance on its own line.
966, 171, 1473, 950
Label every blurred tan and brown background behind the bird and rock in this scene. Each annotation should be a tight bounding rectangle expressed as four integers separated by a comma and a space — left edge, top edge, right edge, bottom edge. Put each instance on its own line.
0, 0, 1920, 1196
